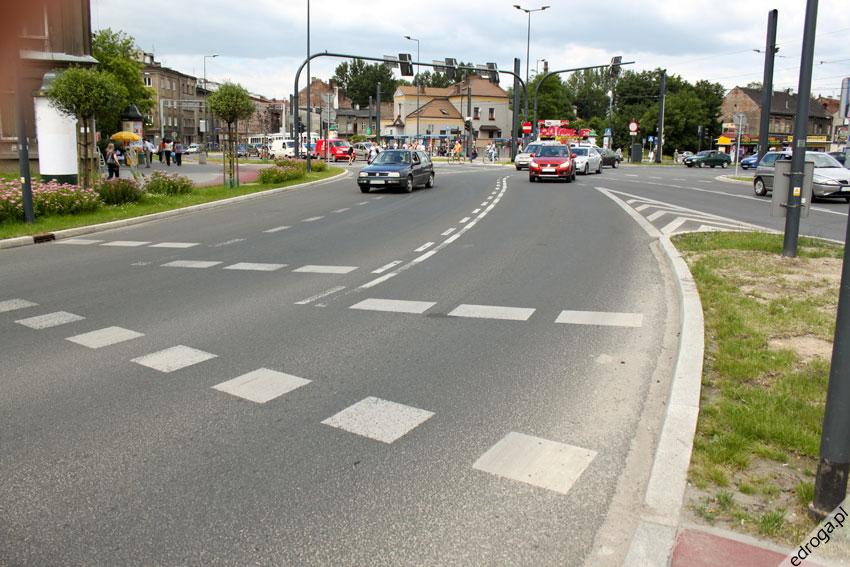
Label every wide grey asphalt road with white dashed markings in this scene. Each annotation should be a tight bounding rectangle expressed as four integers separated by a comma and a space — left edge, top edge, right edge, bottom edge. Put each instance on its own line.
0, 165, 692, 565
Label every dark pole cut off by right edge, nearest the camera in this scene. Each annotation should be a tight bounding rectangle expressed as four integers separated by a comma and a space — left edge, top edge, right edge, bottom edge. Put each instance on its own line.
812, 211, 850, 517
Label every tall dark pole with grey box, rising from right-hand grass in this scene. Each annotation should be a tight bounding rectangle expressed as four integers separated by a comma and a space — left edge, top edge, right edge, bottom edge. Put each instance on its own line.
782, 0, 816, 258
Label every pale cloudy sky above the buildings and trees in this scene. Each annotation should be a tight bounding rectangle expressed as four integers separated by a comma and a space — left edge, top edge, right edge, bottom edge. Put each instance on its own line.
91, 0, 850, 98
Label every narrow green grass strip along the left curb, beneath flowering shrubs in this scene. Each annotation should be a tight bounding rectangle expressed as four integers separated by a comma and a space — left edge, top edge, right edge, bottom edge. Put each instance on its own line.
0, 167, 343, 239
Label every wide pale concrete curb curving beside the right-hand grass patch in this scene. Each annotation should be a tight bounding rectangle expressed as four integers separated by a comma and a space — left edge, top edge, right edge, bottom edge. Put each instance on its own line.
597, 188, 705, 567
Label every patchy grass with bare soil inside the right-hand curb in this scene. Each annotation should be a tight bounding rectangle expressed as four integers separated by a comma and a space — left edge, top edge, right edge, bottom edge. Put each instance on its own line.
674, 233, 843, 545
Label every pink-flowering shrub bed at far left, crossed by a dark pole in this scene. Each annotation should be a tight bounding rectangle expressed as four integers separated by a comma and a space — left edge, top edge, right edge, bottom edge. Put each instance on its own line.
0, 179, 101, 222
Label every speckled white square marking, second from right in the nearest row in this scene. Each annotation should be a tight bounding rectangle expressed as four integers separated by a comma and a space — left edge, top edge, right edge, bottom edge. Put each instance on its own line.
322, 397, 434, 443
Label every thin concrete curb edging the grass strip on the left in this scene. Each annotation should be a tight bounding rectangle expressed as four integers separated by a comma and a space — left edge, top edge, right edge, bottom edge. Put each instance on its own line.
0, 170, 350, 250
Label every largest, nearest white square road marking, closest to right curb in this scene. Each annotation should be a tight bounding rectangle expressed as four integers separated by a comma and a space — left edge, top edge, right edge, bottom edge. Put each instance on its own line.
472, 432, 596, 494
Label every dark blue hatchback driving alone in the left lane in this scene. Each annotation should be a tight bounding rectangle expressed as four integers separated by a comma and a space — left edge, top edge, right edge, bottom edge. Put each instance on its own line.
357, 150, 434, 193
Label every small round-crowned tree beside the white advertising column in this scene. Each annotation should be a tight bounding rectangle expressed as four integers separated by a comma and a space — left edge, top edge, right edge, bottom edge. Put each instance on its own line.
46, 67, 128, 187
